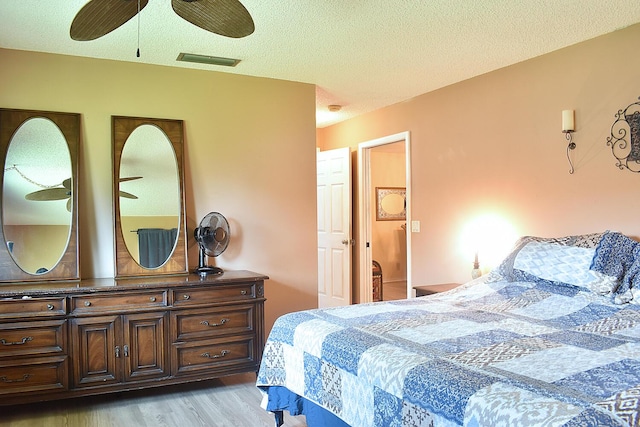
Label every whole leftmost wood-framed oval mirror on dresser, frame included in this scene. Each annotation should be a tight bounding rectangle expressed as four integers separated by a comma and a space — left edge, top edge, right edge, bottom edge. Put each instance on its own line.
0, 109, 80, 281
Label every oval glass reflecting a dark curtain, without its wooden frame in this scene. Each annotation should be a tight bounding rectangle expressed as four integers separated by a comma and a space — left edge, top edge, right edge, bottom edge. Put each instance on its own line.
118, 124, 180, 268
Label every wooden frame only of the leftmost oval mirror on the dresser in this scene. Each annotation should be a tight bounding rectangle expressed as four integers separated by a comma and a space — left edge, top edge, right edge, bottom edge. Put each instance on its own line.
0, 108, 80, 282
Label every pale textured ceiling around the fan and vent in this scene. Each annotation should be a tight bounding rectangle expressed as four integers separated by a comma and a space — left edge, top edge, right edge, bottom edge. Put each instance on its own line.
0, 0, 640, 127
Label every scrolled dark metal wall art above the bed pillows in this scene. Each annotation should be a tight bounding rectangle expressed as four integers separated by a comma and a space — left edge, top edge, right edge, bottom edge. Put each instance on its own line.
607, 97, 640, 173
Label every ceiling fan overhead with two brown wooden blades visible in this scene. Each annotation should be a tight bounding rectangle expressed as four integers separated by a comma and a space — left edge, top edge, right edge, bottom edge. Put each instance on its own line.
70, 0, 255, 41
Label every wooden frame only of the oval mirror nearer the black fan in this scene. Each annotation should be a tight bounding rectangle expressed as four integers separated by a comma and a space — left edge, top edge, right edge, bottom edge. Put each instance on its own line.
111, 116, 189, 278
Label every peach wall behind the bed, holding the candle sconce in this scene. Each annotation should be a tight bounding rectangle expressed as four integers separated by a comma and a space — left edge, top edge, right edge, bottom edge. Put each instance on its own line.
317, 24, 640, 285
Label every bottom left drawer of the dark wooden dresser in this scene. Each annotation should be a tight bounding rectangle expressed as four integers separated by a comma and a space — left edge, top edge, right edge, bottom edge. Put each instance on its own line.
0, 356, 68, 396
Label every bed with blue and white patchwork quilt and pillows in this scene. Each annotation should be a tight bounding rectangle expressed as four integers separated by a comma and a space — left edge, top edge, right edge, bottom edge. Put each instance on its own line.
257, 232, 640, 427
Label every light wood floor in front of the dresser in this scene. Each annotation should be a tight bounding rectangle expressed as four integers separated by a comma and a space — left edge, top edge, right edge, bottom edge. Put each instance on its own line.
0, 373, 306, 427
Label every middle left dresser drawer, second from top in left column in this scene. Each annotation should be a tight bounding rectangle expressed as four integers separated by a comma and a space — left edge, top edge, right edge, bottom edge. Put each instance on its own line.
0, 320, 67, 358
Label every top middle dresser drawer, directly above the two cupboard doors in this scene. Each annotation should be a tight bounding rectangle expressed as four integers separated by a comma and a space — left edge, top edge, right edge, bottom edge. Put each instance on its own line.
71, 290, 168, 314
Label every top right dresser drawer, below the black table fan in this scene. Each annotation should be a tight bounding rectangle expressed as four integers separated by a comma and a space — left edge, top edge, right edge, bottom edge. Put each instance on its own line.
173, 283, 256, 307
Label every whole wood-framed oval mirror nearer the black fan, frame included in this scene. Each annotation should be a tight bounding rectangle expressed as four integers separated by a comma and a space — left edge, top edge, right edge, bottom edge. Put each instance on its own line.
112, 116, 188, 277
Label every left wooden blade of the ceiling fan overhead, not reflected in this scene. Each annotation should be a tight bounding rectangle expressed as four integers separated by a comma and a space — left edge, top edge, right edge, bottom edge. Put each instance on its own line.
69, 0, 149, 41
